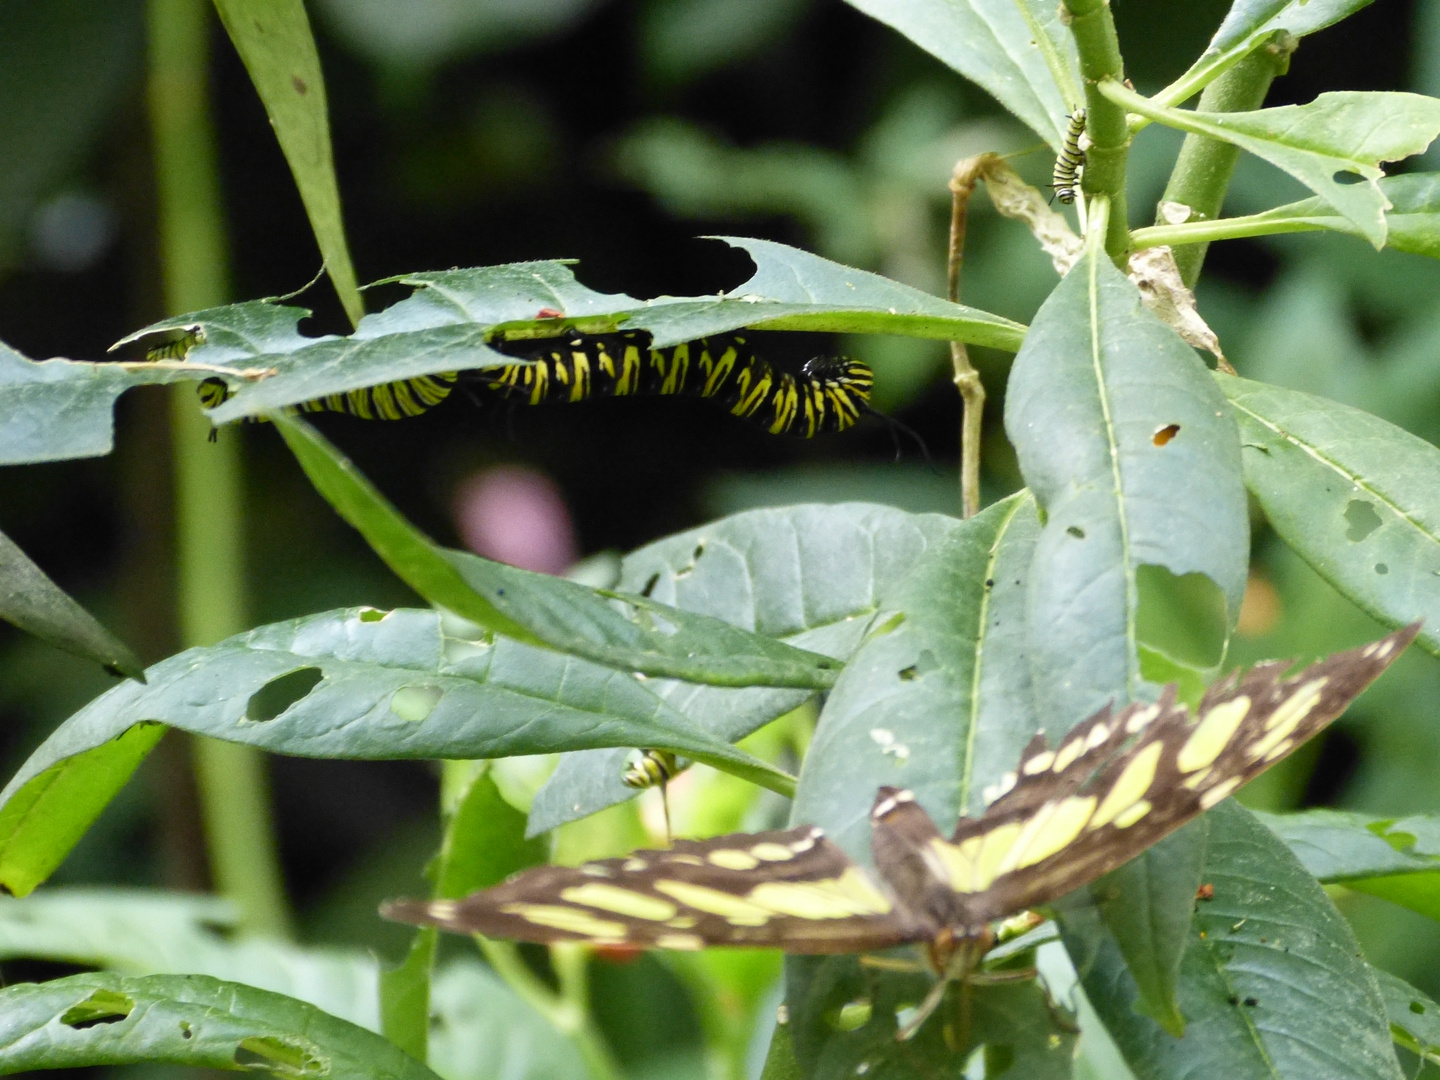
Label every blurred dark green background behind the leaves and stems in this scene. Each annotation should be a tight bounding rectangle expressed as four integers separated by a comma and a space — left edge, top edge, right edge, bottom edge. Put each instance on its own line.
0, 0, 1440, 1071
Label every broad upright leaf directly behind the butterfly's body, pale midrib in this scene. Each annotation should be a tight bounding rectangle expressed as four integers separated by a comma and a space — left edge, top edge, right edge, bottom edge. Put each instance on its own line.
786, 492, 1041, 1070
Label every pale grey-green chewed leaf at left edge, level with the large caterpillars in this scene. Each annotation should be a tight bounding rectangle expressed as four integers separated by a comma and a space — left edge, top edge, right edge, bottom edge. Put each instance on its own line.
0, 344, 206, 465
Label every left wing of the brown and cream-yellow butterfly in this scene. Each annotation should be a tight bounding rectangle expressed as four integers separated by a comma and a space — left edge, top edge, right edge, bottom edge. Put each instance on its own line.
382, 827, 935, 953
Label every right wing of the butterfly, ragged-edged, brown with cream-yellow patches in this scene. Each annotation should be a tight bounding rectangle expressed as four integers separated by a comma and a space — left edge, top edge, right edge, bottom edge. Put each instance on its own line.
932, 625, 1418, 926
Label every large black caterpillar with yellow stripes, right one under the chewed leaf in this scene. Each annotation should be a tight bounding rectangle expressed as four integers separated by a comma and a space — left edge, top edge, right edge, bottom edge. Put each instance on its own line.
468, 333, 874, 438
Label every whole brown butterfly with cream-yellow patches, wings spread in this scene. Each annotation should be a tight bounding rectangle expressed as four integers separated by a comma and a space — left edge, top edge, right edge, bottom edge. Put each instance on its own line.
382, 624, 1420, 1037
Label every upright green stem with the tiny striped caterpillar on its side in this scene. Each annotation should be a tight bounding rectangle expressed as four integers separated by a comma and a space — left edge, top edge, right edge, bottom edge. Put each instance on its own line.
1064, 0, 1130, 262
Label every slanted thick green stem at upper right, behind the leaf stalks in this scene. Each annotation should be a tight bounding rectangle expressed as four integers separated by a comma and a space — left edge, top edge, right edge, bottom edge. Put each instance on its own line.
1157, 33, 1299, 288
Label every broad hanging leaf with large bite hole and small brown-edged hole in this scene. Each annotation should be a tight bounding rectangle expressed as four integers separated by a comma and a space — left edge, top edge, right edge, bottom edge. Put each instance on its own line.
1005, 256, 1250, 733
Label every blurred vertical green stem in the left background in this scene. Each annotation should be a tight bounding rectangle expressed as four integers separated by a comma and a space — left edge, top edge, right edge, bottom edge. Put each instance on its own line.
147, 0, 289, 936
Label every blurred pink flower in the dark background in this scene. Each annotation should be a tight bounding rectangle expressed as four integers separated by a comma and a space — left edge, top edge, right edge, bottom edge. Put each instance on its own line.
455, 465, 576, 573
